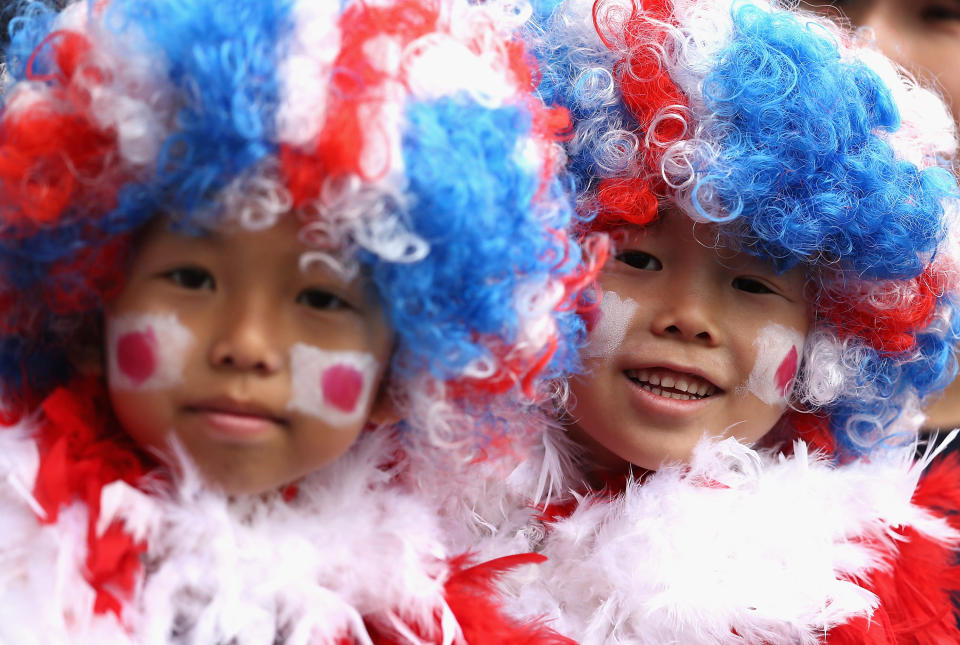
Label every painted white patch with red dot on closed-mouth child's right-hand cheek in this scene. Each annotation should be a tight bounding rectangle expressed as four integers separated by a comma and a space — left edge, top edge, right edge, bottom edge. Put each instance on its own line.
287, 343, 379, 427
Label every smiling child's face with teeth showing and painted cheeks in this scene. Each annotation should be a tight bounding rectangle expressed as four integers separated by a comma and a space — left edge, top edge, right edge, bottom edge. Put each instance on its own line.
569, 213, 810, 470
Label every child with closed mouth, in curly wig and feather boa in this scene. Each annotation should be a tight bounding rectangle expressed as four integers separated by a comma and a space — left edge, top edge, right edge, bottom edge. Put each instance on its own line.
0, 0, 590, 644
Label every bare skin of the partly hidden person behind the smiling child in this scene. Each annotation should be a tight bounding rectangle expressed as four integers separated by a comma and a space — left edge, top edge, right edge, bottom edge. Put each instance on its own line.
801, 0, 960, 430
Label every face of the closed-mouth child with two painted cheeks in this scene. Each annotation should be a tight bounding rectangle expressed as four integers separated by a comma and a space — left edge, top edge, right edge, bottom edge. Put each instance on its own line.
106, 216, 392, 493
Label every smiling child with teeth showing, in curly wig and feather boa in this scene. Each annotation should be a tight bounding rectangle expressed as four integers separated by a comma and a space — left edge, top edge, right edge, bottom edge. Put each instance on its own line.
468, 0, 960, 644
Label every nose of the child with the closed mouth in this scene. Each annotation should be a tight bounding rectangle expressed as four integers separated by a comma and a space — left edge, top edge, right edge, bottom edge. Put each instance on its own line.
210, 302, 283, 375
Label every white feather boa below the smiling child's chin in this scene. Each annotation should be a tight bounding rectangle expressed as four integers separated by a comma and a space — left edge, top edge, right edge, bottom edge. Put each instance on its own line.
496, 439, 960, 645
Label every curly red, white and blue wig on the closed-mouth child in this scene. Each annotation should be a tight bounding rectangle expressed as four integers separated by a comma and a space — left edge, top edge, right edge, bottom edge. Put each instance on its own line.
0, 0, 590, 412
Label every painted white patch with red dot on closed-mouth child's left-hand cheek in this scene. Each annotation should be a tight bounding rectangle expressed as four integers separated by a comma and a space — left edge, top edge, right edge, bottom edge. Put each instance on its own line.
107, 314, 194, 390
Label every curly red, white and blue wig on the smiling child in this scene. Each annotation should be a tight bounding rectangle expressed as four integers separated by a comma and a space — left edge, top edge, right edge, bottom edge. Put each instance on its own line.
529, 0, 960, 456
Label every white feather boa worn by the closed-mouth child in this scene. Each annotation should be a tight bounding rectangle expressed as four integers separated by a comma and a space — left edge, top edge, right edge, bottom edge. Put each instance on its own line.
0, 426, 459, 645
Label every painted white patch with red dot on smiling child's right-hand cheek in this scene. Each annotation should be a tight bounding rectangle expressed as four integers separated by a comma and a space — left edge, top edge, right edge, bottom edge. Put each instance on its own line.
746, 324, 804, 405
